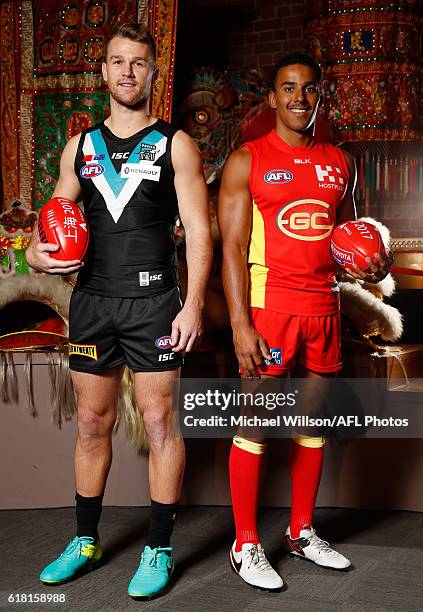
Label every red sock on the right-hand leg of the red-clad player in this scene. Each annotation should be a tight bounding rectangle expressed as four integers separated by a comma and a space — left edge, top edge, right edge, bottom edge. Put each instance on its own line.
289, 438, 323, 538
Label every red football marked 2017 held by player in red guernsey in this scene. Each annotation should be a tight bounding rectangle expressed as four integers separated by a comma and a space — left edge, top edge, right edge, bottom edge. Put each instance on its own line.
330, 221, 386, 272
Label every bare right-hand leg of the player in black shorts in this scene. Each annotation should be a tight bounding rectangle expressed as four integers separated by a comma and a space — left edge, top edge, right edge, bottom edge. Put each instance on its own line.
135, 369, 185, 504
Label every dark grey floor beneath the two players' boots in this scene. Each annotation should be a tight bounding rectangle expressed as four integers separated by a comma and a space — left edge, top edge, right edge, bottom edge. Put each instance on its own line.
0, 507, 423, 612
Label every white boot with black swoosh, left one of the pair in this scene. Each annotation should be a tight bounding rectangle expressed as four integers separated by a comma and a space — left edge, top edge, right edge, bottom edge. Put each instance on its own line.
229, 541, 283, 591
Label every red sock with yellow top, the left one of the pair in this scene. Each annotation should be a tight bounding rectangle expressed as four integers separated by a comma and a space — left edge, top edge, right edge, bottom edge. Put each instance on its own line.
229, 436, 266, 552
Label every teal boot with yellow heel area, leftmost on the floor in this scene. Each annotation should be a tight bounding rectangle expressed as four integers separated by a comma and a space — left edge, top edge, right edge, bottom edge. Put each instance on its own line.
40, 536, 103, 584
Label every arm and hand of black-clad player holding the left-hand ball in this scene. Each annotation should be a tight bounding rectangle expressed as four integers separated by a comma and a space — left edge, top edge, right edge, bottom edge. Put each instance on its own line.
25, 134, 84, 274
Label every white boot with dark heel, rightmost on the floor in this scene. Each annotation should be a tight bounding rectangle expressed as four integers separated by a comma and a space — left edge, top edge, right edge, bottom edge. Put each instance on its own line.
285, 525, 351, 570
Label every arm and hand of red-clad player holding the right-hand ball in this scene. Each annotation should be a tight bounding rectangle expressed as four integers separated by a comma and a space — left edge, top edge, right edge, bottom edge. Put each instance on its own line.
336, 151, 393, 283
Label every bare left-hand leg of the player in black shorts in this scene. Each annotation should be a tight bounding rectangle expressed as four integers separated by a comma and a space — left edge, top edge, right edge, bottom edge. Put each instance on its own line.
72, 366, 122, 497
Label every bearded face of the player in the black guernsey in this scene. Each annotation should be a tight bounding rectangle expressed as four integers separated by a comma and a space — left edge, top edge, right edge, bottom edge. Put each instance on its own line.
102, 37, 154, 108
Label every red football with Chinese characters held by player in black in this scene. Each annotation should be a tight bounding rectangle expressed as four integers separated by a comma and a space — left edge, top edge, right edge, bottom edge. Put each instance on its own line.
38, 198, 90, 261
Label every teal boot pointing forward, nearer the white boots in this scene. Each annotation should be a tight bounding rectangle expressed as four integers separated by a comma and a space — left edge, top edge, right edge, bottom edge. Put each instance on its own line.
128, 546, 174, 598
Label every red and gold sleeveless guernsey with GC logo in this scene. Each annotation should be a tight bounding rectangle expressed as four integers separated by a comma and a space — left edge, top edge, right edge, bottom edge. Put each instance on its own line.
245, 130, 349, 316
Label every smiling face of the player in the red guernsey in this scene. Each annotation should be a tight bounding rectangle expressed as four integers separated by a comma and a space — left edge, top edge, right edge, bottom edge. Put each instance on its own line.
269, 64, 319, 132
